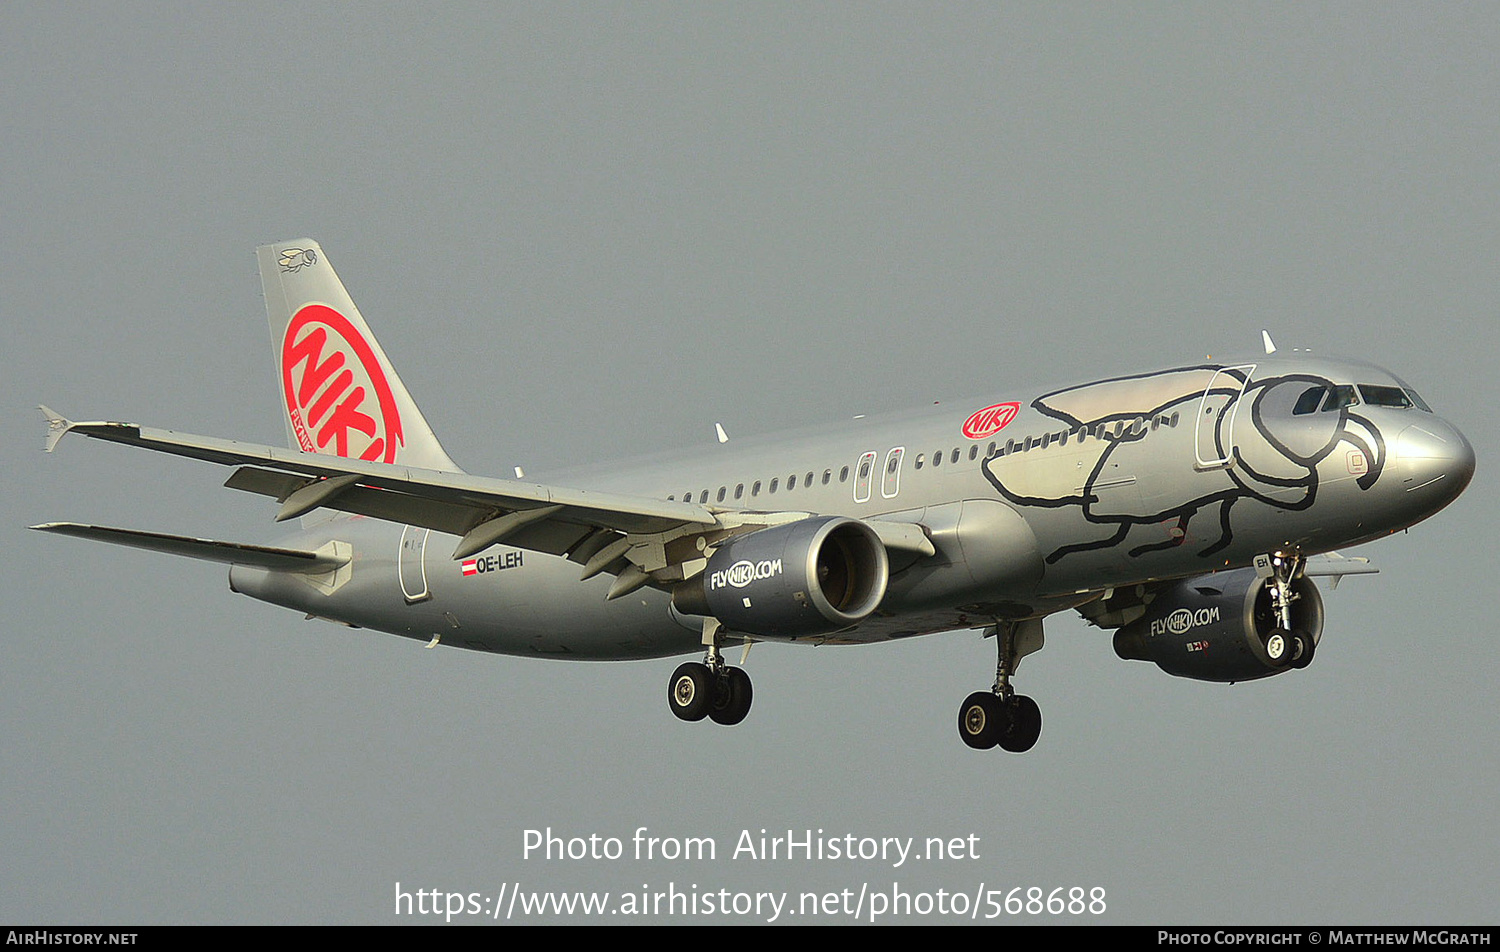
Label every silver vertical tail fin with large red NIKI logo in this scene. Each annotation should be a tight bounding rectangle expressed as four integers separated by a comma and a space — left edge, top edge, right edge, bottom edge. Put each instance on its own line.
255, 238, 462, 472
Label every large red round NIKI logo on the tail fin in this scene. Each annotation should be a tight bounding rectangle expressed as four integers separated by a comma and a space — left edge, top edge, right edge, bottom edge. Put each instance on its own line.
282, 304, 405, 463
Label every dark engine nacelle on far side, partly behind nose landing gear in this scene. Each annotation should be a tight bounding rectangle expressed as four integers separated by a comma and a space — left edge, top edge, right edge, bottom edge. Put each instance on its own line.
1115, 568, 1323, 681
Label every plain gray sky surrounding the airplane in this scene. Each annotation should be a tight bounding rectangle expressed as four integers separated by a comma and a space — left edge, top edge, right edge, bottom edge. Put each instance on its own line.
0, 3, 1500, 924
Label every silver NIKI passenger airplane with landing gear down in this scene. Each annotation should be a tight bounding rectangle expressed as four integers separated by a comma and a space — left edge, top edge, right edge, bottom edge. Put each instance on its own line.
32, 238, 1475, 753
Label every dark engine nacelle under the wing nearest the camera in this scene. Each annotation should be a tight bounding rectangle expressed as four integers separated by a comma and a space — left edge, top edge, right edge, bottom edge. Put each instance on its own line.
672, 516, 890, 637
